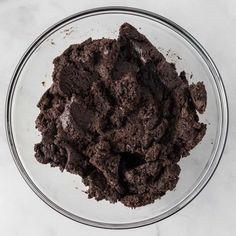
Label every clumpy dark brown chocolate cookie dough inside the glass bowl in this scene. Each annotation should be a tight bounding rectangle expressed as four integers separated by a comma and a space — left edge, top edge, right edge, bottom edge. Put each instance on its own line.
35, 23, 207, 208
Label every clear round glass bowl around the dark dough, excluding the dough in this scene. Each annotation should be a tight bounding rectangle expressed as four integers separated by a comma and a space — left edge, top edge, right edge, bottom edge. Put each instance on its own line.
6, 7, 228, 229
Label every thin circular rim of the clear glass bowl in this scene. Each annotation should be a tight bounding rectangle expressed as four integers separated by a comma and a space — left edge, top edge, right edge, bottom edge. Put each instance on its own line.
5, 6, 229, 229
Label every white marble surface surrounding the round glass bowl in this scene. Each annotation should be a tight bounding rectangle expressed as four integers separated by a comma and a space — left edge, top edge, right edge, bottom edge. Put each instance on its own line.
0, 0, 236, 236
